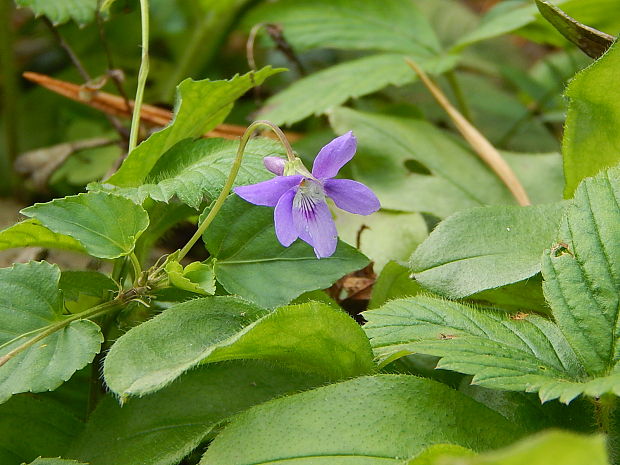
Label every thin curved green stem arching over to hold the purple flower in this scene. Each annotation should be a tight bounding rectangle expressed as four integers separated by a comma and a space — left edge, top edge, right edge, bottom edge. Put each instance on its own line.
177, 120, 295, 260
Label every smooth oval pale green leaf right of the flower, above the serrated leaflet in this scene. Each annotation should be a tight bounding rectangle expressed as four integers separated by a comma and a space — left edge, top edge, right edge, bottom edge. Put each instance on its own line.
411, 203, 564, 298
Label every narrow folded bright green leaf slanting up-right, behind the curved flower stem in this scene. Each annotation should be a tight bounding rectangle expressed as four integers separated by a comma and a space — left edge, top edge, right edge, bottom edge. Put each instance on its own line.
106, 66, 283, 187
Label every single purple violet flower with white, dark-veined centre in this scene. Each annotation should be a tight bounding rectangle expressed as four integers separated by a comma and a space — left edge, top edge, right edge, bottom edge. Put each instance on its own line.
234, 131, 381, 258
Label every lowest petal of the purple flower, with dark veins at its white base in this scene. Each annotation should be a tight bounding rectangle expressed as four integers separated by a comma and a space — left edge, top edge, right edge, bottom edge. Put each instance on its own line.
293, 194, 338, 258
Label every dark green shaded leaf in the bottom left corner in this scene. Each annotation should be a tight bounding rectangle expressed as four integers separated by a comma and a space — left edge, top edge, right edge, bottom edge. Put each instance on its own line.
0, 394, 84, 465
